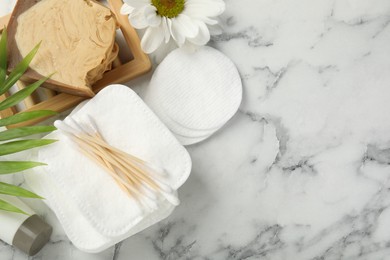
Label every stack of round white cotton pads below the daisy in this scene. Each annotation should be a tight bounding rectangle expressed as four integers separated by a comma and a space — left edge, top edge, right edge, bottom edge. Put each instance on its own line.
144, 47, 242, 145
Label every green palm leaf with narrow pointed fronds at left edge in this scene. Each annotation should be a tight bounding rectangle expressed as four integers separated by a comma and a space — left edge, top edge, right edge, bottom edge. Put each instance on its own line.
0, 28, 56, 214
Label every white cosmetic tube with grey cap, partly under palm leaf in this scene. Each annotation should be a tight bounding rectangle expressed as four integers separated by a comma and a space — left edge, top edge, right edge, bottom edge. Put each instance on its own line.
0, 195, 52, 256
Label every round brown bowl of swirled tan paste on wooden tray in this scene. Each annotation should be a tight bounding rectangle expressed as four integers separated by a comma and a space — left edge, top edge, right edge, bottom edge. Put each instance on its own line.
8, 0, 119, 97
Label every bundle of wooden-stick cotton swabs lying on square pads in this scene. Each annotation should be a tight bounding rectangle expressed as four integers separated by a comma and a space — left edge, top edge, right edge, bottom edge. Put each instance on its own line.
54, 116, 179, 210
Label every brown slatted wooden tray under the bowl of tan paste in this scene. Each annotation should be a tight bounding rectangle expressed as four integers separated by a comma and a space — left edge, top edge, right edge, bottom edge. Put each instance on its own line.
0, 0, 151, 128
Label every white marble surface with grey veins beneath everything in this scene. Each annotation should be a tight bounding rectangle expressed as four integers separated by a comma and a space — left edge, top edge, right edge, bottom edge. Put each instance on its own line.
0, 0, 390, 260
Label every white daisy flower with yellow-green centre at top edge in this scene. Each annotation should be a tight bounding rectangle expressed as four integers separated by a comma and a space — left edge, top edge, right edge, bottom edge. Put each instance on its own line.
121, 0, 225, 53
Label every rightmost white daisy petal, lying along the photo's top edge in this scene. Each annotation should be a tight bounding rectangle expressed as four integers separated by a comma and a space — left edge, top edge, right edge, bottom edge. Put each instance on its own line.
183, 0, 226, 17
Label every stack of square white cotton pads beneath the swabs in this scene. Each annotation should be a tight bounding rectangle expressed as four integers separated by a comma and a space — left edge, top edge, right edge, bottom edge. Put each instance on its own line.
25, 85, 191, 252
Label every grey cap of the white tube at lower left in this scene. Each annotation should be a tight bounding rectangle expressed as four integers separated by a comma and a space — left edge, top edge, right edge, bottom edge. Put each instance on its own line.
12, 215, 53, 256
